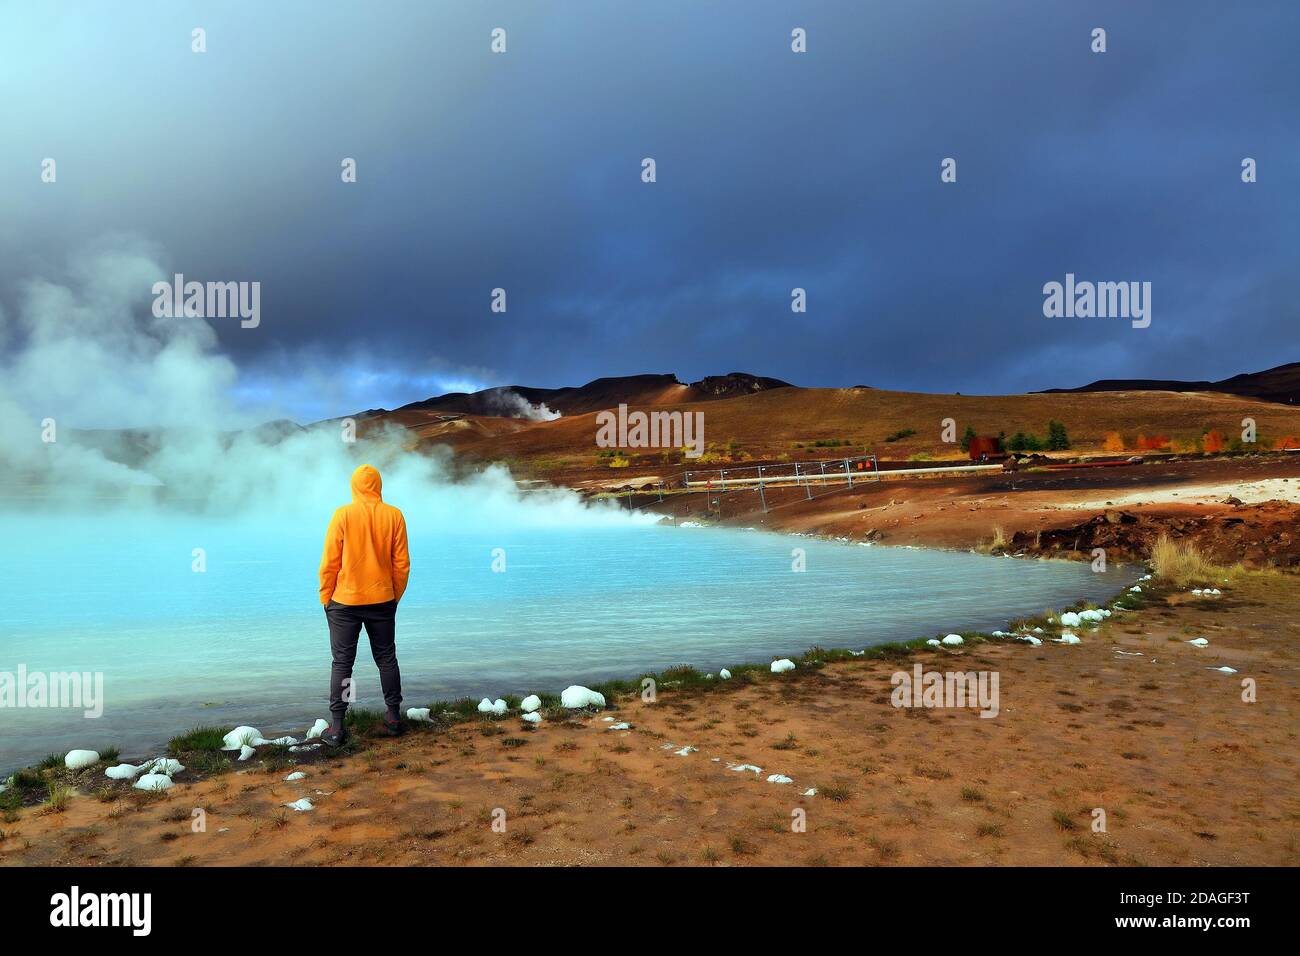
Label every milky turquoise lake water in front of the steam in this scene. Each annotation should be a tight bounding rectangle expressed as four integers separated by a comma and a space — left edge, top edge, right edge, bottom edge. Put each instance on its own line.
0, 509, 1138, 771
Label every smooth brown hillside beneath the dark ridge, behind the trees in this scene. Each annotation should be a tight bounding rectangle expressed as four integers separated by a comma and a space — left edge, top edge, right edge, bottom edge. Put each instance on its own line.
379, 386, 1300, 485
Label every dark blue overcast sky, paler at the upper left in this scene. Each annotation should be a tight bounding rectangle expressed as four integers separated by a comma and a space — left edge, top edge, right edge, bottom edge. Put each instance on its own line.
0, 0, 1300, 418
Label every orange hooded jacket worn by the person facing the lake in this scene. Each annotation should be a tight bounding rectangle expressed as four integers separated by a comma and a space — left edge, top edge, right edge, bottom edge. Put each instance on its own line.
321, 464, 411, 605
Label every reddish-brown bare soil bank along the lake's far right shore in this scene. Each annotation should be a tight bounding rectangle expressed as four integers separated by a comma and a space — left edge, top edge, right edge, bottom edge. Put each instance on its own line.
633, 455, 1300, 567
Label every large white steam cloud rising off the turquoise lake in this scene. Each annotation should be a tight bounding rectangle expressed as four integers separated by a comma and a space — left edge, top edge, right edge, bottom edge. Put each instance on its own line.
0, 241, 642, 529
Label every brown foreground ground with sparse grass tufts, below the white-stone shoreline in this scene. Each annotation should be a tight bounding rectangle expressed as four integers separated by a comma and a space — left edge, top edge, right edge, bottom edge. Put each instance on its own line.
0, 574, 1300, 866
